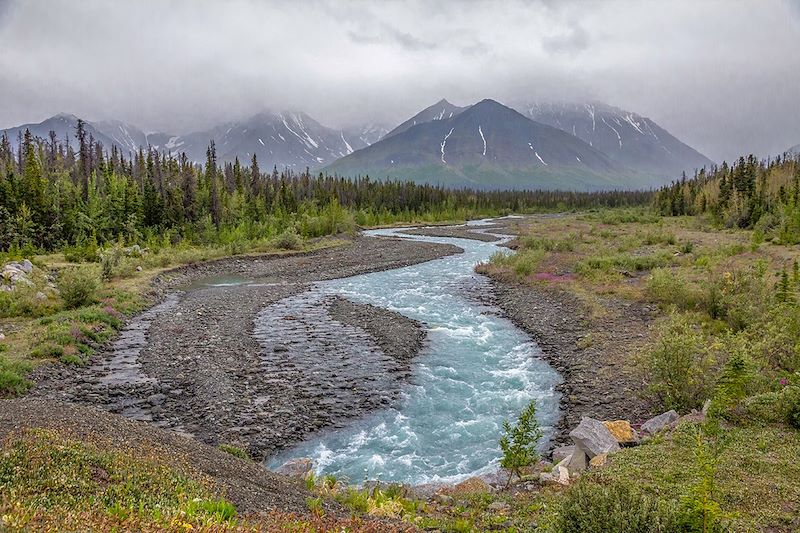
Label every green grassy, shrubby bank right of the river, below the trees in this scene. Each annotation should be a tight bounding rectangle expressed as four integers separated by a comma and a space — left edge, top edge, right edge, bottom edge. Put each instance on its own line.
472, 210, 800, 531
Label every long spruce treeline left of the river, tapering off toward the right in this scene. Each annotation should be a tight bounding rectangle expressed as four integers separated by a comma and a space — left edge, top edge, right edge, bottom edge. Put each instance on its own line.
0, 121, 651, 250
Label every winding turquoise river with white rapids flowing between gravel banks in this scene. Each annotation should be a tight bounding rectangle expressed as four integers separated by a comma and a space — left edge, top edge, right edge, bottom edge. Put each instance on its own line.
266, 221, 560, 484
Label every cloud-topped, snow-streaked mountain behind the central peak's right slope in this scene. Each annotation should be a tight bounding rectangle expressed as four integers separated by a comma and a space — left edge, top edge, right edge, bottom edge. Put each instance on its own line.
519, 103, 714, 180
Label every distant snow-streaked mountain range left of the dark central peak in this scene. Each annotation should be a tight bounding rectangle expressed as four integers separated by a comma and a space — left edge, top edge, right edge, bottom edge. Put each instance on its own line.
0, 112, 387, 169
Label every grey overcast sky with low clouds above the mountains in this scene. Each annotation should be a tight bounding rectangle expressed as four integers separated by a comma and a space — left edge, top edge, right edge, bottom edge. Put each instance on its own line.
0, 0, 800, 161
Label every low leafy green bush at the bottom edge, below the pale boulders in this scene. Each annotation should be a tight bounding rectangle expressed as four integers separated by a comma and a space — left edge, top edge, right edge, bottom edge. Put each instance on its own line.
555, 482, 681, 533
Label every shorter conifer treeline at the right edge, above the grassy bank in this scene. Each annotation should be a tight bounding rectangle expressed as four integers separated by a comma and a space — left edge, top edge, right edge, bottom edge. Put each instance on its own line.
653, 150, 800, 244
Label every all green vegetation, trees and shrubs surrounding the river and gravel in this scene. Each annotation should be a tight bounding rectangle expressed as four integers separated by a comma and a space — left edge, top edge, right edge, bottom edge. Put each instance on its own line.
0, 143, 800, 532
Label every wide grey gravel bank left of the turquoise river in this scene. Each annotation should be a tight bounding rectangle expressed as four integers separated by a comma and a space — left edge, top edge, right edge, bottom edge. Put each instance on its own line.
30, 237, 460, 458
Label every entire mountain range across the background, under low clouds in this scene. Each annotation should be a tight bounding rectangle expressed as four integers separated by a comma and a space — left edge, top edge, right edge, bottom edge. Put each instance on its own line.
0, 99, 714, 191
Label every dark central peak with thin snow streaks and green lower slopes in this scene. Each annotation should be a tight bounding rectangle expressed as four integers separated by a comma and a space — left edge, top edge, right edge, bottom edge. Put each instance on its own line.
324, 100, 641, 190
